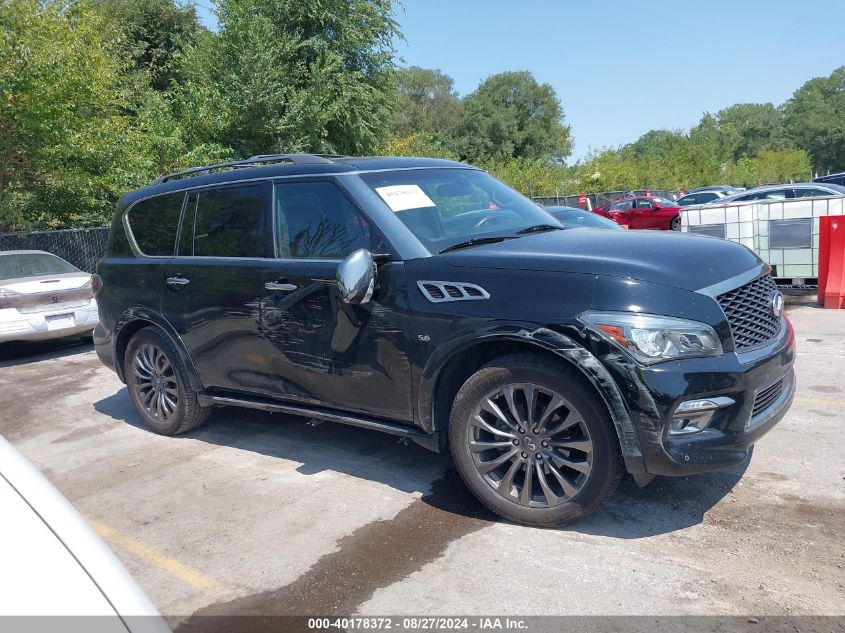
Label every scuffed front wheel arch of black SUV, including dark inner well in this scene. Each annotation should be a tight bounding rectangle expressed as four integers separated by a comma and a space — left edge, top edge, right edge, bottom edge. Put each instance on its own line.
417, 327, 645, 473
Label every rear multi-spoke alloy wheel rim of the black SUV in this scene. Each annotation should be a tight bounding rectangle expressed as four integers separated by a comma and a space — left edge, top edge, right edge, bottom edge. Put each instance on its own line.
132, 343, 179, 422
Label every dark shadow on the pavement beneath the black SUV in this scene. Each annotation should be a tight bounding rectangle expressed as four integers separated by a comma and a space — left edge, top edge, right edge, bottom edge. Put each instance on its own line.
94, 389, 749, 539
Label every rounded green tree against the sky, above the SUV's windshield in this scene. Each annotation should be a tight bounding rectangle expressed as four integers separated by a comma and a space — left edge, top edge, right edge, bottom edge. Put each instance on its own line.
455, 71, 572, 163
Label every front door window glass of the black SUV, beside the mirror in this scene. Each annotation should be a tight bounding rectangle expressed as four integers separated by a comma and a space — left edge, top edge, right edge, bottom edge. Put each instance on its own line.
276, 181, 372, 259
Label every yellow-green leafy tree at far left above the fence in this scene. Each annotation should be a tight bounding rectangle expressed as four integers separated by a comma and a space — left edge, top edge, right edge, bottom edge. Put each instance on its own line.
0, 0, 146, 230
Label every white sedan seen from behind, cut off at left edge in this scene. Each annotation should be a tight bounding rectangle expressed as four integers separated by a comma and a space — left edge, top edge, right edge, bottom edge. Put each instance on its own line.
0, 251, 98, 342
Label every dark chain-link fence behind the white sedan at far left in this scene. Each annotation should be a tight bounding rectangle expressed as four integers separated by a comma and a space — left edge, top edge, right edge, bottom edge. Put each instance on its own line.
0, 226, 109, 273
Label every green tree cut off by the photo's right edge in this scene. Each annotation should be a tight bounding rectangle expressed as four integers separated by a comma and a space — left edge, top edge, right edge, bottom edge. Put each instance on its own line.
783, 66, 845, 172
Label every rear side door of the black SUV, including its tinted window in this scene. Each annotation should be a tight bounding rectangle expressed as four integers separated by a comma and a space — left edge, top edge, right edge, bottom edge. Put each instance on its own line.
162, 182, 270, 391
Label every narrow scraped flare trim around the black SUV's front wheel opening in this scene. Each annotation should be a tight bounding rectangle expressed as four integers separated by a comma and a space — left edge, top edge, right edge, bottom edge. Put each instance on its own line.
417, 323, 646, 474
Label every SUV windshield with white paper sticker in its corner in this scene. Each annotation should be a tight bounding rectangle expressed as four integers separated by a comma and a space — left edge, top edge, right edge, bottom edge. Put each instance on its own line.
361, 169, 560, 253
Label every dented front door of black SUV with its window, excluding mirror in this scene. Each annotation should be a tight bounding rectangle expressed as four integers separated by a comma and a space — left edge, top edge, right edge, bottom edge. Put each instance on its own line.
261, 180, 413, 421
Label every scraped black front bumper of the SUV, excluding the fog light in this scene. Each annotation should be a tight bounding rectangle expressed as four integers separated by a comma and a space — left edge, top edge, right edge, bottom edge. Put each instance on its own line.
605, 317, 795, 475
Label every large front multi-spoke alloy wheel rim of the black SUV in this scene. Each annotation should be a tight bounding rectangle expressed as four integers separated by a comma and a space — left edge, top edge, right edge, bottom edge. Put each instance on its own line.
467, 383, 593, 508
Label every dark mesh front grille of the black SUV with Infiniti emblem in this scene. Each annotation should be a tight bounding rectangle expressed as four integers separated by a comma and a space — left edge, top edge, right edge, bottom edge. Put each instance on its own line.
717, 275, 780, 352
